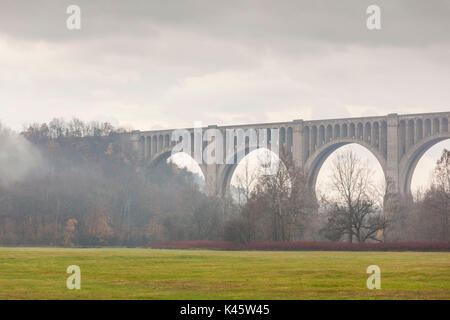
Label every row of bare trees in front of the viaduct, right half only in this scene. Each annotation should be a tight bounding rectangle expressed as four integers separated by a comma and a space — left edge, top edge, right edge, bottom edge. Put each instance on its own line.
230, 149, 450, 242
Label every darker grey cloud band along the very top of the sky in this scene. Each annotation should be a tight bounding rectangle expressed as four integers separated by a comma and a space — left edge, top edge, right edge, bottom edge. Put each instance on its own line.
0, 0, 450, 46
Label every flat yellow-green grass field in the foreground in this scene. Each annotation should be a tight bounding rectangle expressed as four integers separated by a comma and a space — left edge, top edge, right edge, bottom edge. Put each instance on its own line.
0, 248, 450, 299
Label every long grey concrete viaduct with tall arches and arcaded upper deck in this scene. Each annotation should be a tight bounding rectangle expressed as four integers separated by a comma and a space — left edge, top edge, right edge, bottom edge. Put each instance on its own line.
121, 112, 450, 196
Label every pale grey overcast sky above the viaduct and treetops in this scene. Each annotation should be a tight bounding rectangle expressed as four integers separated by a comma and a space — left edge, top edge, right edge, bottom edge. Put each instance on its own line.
0, 0, 450, 190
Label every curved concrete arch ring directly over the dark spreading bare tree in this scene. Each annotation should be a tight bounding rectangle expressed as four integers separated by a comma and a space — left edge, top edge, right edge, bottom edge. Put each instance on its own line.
305, 138, 387, 192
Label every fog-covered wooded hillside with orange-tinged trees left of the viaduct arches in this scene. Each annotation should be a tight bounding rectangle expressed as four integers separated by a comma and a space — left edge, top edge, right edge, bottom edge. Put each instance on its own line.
0, 119, 237, 246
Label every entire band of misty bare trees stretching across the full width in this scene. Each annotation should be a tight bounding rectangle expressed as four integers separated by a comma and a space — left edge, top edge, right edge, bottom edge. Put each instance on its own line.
0, 119, 450, 246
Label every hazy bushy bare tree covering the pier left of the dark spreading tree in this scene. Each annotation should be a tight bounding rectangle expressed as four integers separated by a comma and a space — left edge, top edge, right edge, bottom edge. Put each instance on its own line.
234, 154, 316, 241
